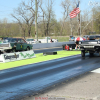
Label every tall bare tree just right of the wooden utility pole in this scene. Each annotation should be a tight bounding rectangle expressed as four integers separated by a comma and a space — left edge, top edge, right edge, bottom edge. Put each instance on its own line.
39, 0, 54, 36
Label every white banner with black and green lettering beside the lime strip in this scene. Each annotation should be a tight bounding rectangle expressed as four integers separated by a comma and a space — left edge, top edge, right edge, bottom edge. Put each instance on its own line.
0, 50, 36, 63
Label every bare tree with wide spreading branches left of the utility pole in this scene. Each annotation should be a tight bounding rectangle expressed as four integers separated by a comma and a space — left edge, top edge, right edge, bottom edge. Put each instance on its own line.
11, 2, 35, 38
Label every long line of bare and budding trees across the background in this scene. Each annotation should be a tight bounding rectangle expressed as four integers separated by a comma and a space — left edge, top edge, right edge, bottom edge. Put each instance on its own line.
0, 0, 100, 38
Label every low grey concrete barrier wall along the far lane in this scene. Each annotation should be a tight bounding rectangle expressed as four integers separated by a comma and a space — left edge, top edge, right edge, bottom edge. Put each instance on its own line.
33, 41, 75, 49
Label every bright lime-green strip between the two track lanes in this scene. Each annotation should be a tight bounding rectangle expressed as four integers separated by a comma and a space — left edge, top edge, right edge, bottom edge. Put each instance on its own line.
0, 51, 81, 70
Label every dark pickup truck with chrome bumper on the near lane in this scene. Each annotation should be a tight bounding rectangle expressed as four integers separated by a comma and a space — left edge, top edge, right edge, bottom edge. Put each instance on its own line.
79, 36, 100, 57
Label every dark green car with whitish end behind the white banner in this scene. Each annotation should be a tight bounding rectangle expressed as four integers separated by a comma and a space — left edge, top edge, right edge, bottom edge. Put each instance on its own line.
0, 38, 33, 54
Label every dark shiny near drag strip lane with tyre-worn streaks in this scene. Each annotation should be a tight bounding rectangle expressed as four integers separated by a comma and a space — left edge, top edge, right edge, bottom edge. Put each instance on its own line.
0, 48, 100, 100
